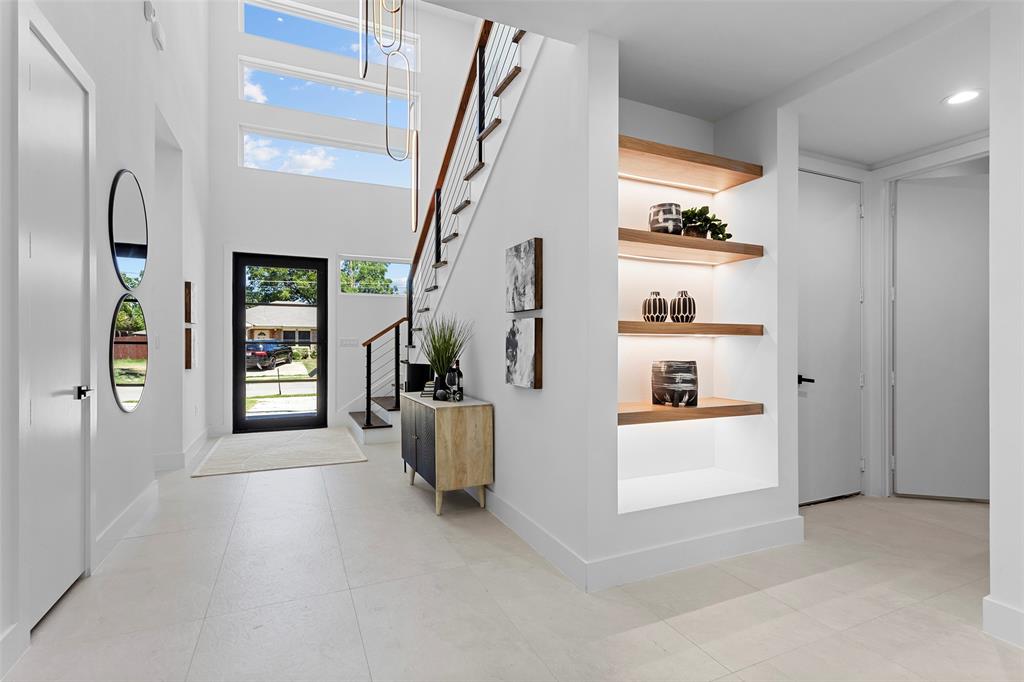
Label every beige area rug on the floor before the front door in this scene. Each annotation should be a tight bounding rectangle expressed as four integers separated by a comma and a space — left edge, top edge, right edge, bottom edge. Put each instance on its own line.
193, 427, 367, 478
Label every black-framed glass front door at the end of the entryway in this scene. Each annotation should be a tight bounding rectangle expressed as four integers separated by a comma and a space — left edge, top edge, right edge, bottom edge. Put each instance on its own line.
231, 253, 330, 433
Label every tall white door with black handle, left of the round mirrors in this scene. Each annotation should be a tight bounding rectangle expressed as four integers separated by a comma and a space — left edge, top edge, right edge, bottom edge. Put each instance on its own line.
18, 19, 89, 627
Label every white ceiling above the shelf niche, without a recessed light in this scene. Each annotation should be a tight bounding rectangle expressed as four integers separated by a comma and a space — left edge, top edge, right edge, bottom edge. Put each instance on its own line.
421, 0, 945, 121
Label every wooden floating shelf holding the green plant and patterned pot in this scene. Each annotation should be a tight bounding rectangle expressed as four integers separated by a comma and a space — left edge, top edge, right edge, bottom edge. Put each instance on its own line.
618, 227, 765, 265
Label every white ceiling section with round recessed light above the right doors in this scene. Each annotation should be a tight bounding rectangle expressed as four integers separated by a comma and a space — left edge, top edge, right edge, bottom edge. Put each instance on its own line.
798, 12, 989, 167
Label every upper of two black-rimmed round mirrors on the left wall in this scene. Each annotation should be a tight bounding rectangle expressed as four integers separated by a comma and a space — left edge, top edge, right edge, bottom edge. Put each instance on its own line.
110, 169, 150, 291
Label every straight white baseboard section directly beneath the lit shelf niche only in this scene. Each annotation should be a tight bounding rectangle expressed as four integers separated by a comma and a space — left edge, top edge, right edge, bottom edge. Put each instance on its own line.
587, 514, 804, 592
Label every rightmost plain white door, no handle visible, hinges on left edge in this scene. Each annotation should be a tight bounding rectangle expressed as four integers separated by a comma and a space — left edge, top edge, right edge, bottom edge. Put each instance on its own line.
893, 175, 988, 500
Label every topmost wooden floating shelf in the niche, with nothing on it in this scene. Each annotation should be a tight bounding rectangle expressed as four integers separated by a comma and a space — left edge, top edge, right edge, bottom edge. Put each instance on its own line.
618, 135, 764, 194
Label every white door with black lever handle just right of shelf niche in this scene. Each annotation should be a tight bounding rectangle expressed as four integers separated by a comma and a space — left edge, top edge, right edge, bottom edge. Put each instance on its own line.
784, 172, 862, 503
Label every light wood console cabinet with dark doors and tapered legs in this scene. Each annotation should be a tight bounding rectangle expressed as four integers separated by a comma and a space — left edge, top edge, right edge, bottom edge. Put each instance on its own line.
401, 393, 495, 515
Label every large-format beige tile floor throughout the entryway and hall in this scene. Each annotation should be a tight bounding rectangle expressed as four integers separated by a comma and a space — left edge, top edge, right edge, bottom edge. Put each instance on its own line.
6, 436, 1024, 682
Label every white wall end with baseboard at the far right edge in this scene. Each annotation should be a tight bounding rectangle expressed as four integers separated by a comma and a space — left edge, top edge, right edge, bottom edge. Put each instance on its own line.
983, 3, 1024, 646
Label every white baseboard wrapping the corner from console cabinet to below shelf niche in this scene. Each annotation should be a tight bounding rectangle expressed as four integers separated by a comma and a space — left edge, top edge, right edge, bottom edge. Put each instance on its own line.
483, 489, 804, 592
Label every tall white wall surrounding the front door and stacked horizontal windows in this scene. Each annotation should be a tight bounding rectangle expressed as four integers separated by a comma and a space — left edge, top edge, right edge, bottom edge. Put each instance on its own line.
204, 0, 478, 434
